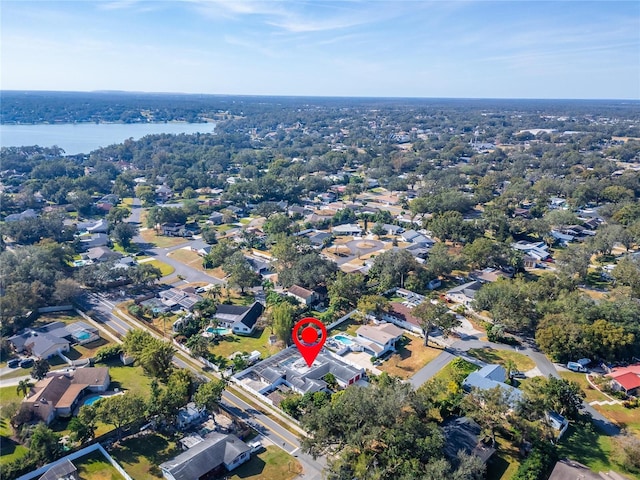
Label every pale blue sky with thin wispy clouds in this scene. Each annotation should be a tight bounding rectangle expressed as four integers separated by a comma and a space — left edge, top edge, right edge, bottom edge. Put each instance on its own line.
0, 0, 640, 99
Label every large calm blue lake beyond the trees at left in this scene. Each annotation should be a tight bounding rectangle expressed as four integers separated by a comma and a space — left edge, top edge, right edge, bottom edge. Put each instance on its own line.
0, 123, 216, 155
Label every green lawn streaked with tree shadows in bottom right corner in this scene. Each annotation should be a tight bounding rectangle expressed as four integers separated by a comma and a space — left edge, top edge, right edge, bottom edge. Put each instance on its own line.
558, 422, 640, 479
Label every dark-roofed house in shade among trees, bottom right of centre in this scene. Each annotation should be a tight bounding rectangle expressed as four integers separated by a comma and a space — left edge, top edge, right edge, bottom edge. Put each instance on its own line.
442, 417, 496, 463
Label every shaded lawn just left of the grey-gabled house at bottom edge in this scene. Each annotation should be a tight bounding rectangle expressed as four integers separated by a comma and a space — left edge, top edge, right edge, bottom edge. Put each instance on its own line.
110, 433, 180, 480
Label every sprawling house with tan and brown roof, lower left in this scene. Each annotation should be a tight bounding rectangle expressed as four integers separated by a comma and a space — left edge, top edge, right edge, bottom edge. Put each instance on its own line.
20, 367, 111, 424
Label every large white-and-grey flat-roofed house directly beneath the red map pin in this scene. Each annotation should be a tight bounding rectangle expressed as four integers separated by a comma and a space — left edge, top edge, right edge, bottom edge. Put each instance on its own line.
234, 347, 364, 397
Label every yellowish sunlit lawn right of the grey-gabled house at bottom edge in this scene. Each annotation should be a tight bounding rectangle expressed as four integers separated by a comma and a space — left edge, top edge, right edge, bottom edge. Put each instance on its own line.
227, 446, 302, 480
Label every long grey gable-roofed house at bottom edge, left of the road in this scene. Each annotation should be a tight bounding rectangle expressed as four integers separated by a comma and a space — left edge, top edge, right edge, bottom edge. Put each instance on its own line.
160, 433, 251, 480
